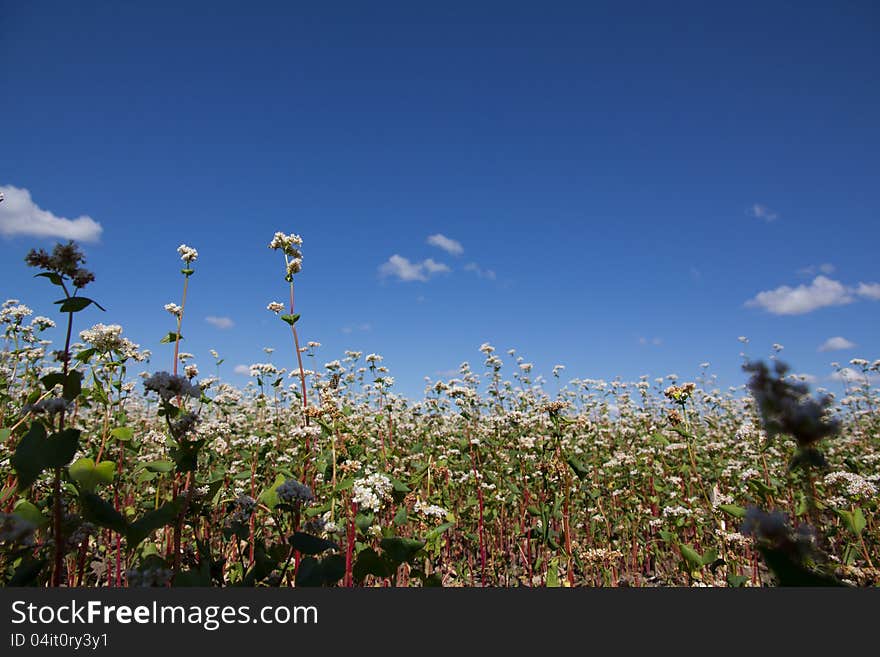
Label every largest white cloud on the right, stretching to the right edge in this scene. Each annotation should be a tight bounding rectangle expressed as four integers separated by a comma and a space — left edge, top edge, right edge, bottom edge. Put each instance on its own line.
746, 276, 880, 315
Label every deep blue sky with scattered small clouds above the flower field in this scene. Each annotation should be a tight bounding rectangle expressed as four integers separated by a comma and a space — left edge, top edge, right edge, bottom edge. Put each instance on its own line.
0, 2, 880, 395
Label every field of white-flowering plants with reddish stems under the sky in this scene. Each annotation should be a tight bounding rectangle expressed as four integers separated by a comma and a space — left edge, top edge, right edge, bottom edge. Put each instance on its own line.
0, 233, 880, 587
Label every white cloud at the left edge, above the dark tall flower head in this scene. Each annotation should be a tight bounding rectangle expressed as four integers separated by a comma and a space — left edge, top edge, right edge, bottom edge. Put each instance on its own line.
0, 185, 104, 242
